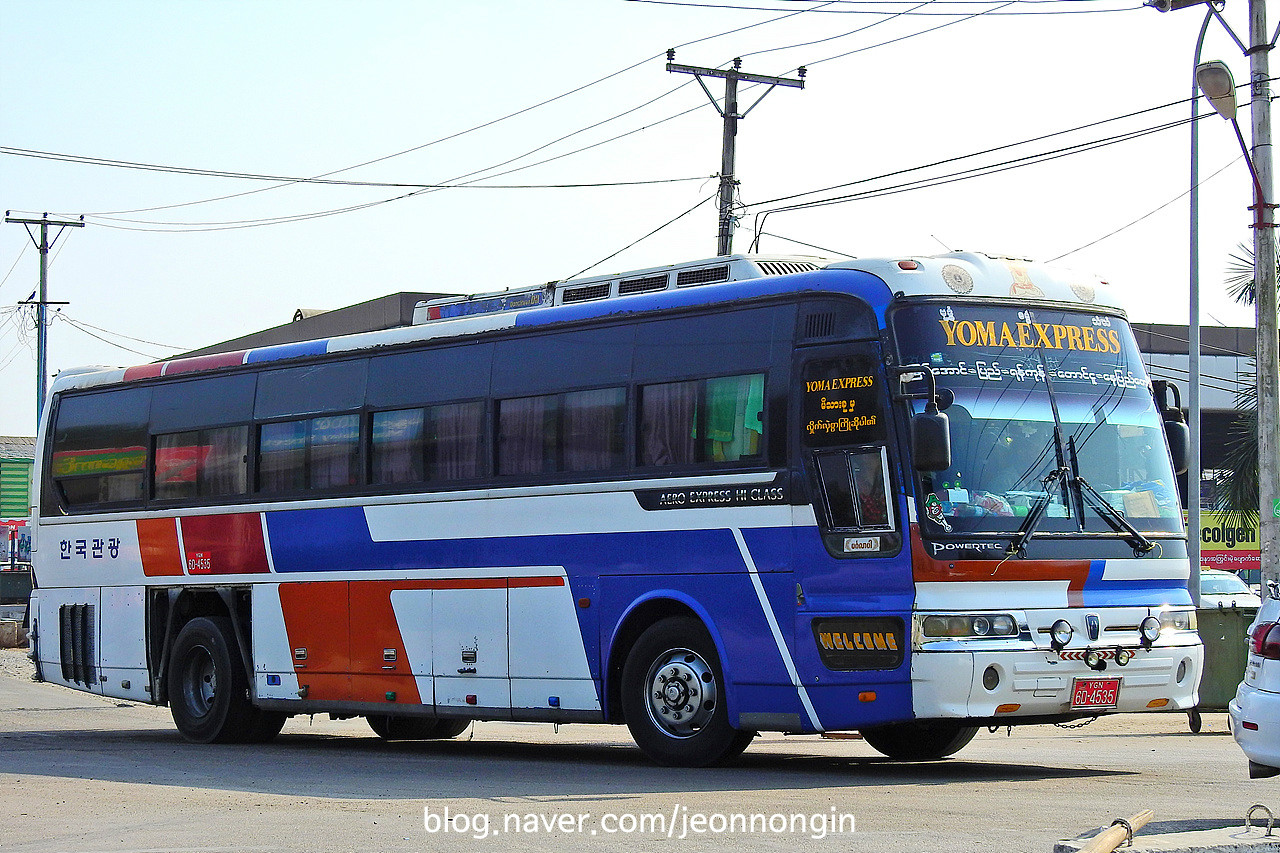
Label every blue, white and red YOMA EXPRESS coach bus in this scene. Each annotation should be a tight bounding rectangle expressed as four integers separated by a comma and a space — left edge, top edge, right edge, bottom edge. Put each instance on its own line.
31, 254, 1203, 766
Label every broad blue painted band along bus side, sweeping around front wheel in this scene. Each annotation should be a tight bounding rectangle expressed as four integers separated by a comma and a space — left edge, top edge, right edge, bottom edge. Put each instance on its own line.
266, 507, 911, 727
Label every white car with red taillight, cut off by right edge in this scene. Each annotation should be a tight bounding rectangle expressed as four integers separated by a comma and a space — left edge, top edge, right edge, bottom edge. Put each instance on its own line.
1228, 596, 1280, 779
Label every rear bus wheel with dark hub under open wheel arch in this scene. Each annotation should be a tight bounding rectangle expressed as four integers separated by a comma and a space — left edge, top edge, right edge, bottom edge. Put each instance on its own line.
169, 616, 257, 743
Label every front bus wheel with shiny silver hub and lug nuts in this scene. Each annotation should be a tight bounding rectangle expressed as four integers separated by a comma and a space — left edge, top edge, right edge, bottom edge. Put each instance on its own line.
622, 616, 755, 767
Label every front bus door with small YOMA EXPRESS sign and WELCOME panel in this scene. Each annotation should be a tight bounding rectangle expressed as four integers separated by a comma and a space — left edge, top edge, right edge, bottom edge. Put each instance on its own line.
792, 341, 913, 684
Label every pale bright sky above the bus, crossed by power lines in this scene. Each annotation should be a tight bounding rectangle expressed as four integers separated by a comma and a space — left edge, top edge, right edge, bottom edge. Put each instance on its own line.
0, 0, 1259, 435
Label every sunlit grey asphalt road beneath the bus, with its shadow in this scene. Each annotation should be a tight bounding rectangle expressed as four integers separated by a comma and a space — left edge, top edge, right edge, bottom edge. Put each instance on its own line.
0, 651, 1280, 853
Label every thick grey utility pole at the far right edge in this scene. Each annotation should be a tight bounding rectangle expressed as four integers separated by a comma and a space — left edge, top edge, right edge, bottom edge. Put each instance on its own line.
1248, 0, 1280, 597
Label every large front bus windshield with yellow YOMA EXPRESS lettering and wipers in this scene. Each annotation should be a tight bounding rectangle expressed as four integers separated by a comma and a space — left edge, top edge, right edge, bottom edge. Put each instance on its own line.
893, 304, 1181, 534
